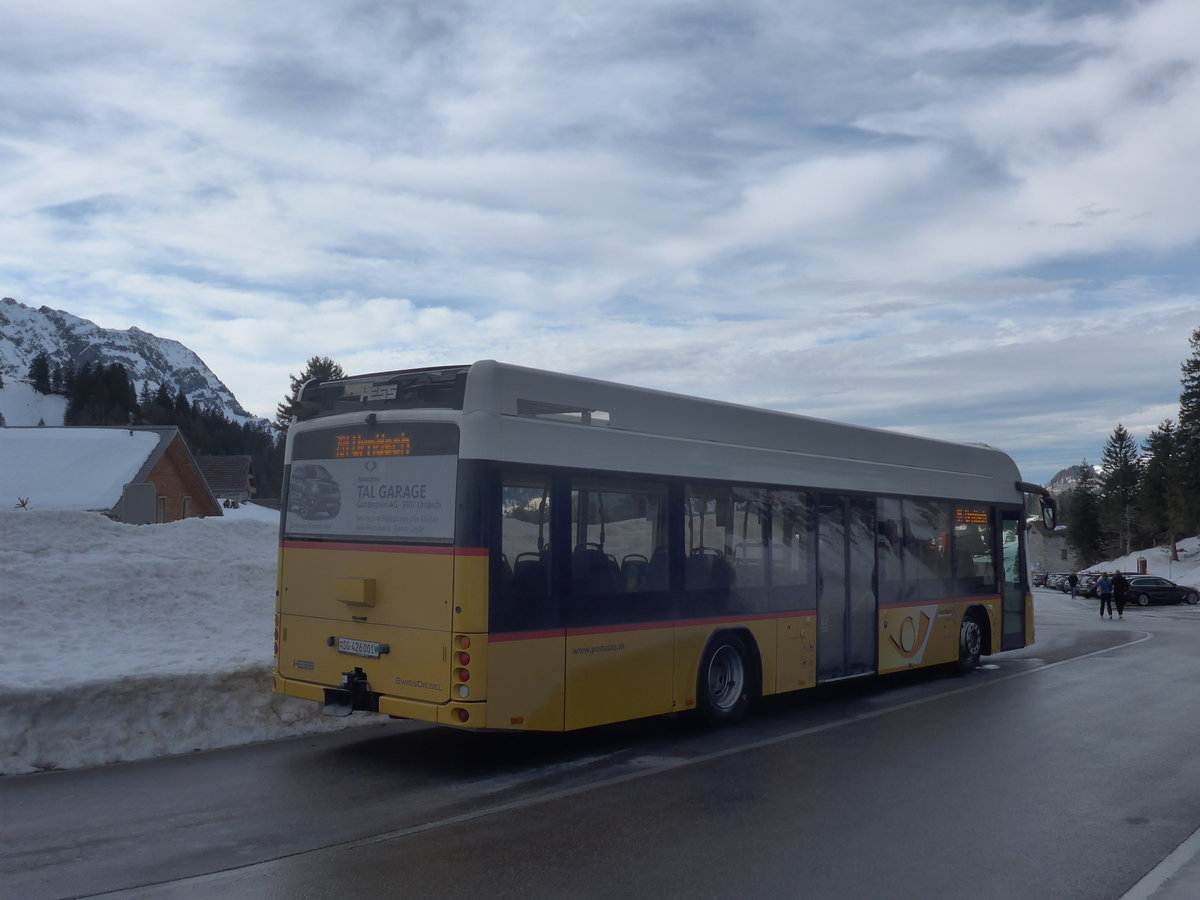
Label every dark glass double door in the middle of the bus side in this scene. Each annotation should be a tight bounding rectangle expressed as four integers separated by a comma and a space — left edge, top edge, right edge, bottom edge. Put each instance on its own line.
817, 494, 878, 682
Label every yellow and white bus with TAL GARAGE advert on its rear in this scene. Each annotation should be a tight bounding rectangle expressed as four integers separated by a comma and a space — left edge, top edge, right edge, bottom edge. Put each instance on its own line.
274, 360, 1054, 731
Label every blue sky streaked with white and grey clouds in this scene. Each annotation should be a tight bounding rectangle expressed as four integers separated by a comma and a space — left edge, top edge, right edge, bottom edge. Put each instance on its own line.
0, 0, 1200, 482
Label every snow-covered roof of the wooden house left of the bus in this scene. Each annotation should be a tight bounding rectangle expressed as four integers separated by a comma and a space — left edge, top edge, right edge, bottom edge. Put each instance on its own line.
0, 426, 178, 512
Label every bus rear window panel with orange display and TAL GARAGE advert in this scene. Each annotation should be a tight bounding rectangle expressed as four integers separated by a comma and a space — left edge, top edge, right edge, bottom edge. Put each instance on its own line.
283, 422, 458, 541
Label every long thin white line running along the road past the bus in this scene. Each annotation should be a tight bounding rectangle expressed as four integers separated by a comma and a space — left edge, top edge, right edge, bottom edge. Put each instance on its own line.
79, 631, 1152, 900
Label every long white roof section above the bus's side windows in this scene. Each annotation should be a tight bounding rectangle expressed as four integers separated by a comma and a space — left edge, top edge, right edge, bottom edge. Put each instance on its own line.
306, 360, 1022, 504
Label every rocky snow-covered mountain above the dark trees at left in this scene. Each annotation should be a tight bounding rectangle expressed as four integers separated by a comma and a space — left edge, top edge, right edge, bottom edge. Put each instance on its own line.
0, 298, 264, 422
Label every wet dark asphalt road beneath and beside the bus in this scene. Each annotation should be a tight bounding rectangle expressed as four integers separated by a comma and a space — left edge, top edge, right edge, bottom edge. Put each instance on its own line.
0, 590, 1200, 900
